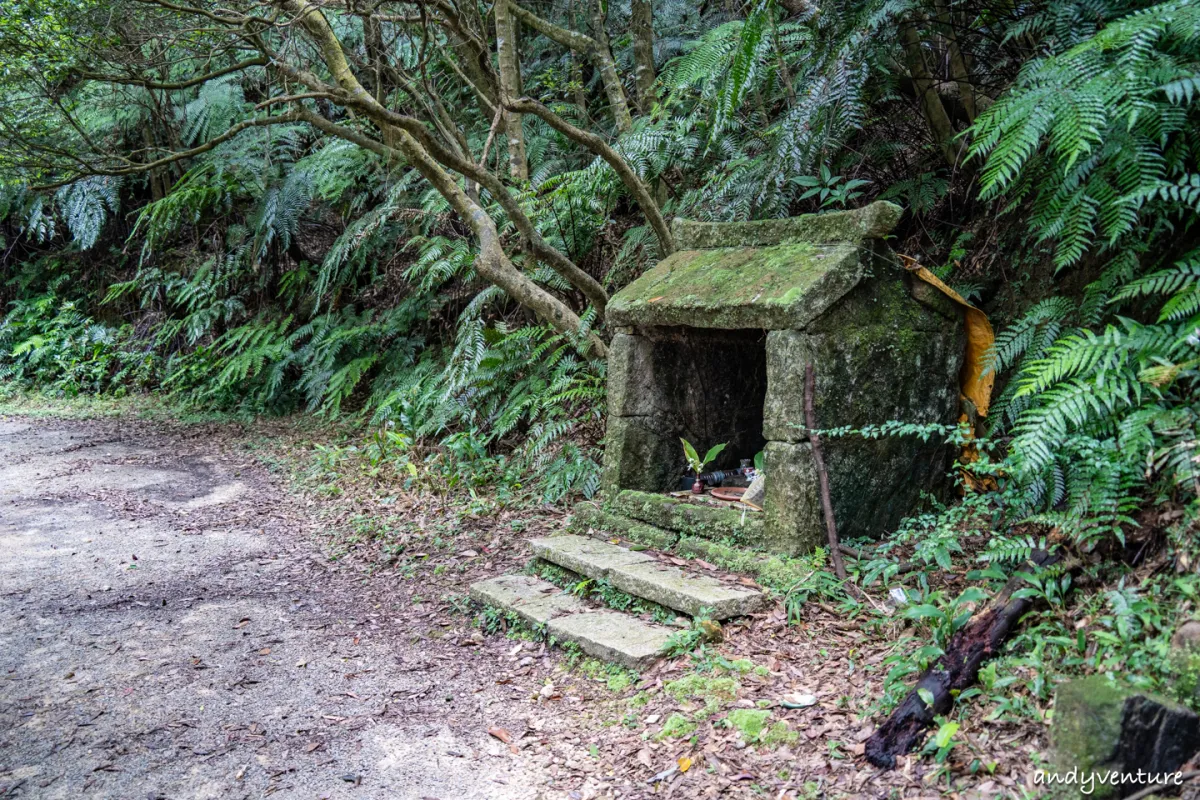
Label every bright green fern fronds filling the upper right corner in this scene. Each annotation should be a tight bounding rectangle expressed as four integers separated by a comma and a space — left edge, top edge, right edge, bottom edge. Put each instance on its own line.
971, 1, 1200, 267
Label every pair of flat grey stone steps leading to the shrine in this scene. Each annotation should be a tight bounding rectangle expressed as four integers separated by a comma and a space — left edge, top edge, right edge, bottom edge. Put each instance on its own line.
470, 534, 764, 669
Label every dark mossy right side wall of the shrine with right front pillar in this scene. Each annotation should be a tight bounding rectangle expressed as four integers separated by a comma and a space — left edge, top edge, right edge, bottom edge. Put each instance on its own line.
763, 267, 962, 542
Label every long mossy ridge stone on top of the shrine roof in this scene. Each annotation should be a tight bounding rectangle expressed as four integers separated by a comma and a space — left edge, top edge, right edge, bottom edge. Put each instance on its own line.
671, 201, 904, 249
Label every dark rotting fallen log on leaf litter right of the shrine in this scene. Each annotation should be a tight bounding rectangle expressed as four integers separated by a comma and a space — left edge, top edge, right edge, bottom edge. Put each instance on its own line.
865, 551, 1062, 769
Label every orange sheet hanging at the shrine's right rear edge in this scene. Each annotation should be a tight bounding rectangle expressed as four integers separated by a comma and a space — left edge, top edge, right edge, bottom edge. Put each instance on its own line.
900, 255, 996, 489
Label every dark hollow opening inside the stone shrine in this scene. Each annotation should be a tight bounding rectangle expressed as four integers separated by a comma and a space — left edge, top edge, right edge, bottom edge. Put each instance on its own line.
641, 327, 767, 476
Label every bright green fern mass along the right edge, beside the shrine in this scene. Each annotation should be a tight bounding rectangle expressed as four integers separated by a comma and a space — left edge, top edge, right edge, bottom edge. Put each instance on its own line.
971, 0, 1200, 545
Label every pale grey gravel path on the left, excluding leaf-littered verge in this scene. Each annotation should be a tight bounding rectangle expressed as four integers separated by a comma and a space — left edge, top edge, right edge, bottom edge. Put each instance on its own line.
0, 417, 549, 800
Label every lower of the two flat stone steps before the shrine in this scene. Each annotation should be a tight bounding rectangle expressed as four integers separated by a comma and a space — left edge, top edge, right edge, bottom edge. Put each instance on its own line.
470, 575, 676, 669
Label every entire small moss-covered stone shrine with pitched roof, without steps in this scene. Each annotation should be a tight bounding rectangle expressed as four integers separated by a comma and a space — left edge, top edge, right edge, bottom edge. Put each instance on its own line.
602, 203, 964, 551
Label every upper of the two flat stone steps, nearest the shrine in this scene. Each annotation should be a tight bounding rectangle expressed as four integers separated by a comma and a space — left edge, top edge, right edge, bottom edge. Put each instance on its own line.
529, 534, 766, 620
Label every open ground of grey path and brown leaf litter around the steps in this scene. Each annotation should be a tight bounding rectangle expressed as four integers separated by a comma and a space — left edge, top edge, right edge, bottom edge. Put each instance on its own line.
0, 415, 1045, 800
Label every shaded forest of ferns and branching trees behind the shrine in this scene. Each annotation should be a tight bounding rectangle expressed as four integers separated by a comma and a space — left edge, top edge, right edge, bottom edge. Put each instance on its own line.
0, 0, 1200, 729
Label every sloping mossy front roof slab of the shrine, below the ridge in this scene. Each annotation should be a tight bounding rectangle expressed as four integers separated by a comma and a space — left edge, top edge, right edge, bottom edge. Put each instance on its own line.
606, 242, 863, 330
